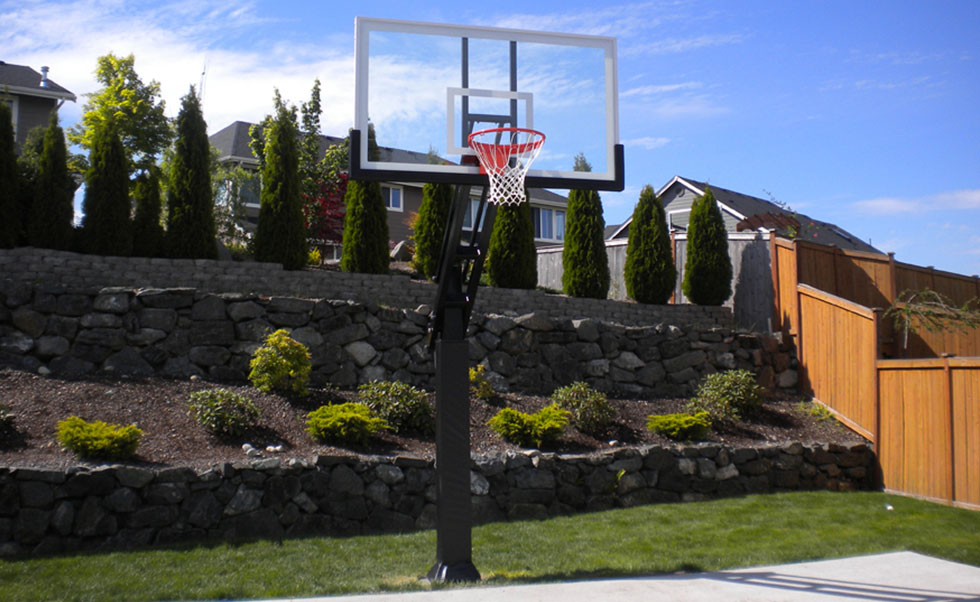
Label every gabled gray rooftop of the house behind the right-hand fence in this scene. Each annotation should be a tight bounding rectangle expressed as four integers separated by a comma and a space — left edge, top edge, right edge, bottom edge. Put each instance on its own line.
608, 176, 881, 253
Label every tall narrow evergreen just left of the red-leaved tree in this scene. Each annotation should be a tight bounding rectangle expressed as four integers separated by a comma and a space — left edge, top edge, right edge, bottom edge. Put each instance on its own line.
254, 90, 307, 270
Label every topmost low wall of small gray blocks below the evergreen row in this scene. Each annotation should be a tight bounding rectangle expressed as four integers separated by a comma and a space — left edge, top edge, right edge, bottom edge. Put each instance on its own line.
0, 247, 734, 328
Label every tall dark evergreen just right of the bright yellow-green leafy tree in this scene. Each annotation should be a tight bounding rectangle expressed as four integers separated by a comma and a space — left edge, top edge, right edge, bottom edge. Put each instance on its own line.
167, 86, 218, 259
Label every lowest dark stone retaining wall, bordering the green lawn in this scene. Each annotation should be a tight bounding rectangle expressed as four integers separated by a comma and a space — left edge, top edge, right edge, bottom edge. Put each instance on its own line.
0, 443, 875, 557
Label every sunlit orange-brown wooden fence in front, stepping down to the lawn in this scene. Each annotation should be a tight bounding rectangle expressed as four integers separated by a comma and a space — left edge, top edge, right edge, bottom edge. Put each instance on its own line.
794, 284, 980, 509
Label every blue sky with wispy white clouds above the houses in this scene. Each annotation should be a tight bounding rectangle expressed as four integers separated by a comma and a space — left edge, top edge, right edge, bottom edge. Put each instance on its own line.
0, 0, 980, 274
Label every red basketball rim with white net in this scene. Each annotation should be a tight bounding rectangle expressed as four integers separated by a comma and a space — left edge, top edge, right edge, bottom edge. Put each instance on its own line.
469, 128, 544, 204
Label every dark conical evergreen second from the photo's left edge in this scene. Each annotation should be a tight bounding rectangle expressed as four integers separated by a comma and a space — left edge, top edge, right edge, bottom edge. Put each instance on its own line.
25, 111, 74, 249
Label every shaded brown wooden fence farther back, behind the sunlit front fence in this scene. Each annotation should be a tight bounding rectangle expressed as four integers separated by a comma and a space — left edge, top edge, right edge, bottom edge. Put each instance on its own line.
770, 236, 980, 358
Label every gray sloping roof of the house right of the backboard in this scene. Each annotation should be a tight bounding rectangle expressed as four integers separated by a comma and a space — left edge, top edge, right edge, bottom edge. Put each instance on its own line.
609, 176, 881, 253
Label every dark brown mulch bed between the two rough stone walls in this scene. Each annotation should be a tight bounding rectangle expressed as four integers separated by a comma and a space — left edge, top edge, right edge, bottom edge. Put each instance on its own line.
0, 369, 862, 468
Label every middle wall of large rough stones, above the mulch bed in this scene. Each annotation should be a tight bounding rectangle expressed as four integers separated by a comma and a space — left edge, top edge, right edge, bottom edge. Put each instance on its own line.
0, 281, 797, 397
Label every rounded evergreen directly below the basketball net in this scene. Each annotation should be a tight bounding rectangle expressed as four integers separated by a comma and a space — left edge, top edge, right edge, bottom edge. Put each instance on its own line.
487, 197, 538, 289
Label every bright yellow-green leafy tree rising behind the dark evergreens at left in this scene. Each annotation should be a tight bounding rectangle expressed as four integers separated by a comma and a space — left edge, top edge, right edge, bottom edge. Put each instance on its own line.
68, 52, 172, 174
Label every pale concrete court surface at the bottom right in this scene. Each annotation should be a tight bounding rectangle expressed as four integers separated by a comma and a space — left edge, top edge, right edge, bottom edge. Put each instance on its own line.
256, 552, 980, 602
